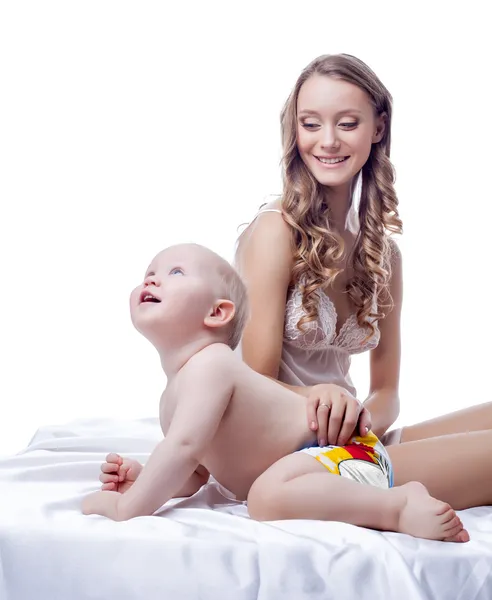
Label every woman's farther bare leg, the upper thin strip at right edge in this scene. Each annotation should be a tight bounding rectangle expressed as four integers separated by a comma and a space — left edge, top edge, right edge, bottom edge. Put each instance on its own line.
401, 402, 492, 443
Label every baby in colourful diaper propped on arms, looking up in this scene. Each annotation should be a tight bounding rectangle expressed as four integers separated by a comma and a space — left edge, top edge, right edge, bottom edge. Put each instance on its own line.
82, 244, 469, 542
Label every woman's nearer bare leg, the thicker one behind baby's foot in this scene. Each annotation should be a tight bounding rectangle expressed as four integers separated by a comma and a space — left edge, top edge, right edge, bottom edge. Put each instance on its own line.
386, 429, 492, 510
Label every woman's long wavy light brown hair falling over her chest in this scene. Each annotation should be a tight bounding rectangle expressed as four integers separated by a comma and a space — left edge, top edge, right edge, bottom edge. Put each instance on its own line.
281, 54, 402, 337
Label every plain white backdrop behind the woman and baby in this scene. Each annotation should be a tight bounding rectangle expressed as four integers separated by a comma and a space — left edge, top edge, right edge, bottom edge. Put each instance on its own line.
0, 0, 492, 454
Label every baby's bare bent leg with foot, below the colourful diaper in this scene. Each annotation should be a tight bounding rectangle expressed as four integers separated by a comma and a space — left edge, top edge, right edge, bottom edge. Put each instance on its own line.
248, 453, 469, 542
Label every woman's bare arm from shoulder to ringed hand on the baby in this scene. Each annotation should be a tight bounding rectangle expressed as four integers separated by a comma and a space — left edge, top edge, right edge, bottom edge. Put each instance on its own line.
236, 207, 371, 445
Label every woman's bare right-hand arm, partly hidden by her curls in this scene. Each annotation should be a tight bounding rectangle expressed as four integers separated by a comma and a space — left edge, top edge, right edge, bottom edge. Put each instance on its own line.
364, 242, 403, 436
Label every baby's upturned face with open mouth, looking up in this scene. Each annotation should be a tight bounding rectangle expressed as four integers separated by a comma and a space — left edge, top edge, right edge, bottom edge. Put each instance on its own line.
130, 245, 216, 343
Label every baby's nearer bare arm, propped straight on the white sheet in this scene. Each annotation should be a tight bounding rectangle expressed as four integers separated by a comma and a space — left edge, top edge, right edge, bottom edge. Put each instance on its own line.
82, 345, 235, 521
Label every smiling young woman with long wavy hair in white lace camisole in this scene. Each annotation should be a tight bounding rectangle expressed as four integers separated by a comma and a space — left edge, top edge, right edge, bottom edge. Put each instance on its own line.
236, 55, 492, 509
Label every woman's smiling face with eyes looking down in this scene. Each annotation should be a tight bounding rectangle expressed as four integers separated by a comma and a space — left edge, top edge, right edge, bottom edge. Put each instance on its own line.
297, 75, 385, 187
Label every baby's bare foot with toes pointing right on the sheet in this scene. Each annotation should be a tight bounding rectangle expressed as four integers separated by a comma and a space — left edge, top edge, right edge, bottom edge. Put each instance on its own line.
391, 481, 470, 542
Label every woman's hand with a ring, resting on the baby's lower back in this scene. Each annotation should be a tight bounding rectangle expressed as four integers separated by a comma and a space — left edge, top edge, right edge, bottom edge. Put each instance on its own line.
307, 383, 371, 446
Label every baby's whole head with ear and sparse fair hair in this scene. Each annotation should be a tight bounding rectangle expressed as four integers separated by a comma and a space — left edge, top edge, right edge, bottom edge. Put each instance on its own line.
130, 244, 248, 350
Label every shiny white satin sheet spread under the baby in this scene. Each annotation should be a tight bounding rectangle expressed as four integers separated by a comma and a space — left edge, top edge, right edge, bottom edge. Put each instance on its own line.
0, 419, 492, 600
